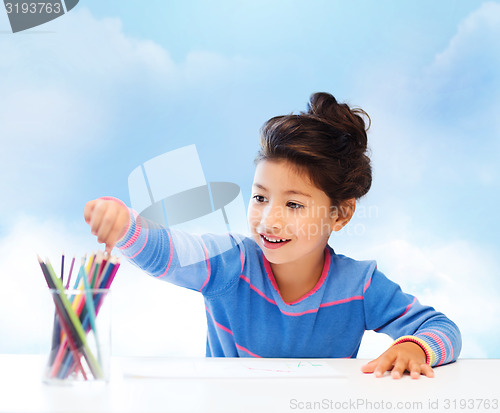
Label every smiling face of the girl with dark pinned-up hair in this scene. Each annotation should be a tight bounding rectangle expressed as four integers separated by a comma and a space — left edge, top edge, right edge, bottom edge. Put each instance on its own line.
248, 161, 344, 264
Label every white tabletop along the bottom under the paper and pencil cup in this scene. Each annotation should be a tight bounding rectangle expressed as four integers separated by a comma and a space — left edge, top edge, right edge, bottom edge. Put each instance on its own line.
0, 355, 500, 413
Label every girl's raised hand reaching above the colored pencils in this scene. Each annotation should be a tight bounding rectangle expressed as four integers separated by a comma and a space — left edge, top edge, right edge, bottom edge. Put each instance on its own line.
84, 198, 130, 253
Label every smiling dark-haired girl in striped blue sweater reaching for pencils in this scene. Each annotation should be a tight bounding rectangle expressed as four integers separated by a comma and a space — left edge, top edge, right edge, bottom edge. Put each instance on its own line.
85, 93, 461, 378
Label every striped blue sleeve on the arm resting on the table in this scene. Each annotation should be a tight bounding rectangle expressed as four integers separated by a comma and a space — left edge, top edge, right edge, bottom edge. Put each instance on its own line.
364, 270, 462, 366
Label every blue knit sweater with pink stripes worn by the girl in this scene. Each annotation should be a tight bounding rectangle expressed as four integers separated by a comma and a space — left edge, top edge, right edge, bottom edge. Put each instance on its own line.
117, 208, 461, 366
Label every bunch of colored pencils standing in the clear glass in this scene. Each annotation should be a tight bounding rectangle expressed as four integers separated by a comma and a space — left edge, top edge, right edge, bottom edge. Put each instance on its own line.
38, 252, 120, 380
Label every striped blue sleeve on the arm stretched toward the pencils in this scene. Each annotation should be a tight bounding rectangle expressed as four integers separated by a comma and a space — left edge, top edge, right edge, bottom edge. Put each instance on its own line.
116, 202, 244, 294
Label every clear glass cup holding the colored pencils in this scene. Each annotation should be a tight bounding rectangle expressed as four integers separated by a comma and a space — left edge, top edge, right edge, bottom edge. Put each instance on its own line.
43, 289, 111, 384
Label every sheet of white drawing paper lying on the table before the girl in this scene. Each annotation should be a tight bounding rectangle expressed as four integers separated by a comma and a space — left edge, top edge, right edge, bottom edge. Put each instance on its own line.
123, 358, 343, 379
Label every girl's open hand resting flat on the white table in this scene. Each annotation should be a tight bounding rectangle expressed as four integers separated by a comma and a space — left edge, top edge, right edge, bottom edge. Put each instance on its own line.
361, 342, 434, 379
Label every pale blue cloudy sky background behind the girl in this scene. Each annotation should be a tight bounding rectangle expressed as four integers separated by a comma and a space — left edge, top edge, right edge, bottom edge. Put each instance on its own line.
0, 0, 500, 357
